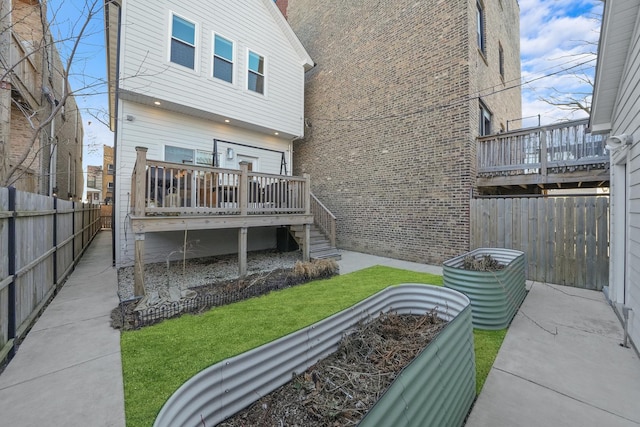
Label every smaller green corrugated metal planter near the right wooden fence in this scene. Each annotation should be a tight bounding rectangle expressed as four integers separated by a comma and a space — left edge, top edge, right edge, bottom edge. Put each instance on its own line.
442, 248, 527, 330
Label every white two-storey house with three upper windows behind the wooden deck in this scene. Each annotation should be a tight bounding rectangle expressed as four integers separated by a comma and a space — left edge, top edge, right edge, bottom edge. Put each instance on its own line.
105, 0, 313, 267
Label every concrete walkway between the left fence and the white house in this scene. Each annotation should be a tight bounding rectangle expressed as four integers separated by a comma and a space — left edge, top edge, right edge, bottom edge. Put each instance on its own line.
0, 231, 125, 427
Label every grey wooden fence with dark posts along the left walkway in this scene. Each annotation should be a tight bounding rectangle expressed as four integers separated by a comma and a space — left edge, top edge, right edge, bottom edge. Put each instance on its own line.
0, 188, 100, 362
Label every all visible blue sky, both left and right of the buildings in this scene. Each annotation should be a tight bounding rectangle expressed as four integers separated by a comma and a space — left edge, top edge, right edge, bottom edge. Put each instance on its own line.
48, 0, 602, 170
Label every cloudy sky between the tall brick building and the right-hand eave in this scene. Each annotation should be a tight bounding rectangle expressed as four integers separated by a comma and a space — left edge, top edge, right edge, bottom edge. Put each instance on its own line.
519, 0, 602, 126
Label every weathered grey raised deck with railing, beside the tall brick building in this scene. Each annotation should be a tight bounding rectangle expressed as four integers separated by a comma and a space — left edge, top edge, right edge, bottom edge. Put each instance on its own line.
477, 119, 609, 194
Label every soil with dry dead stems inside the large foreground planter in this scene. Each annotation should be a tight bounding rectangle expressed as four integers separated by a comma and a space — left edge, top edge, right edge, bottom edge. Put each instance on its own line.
218, 313, 446, 427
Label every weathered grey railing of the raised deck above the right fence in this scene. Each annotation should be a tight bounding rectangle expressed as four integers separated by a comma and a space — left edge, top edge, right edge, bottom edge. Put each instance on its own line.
478, 119, 609, 177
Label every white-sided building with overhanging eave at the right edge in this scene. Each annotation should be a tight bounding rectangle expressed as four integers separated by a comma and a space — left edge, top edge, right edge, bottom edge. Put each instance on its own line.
590, 0, 640, 349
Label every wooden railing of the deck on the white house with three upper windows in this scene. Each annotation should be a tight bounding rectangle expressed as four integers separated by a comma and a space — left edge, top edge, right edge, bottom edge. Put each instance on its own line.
132, 147, 310, 217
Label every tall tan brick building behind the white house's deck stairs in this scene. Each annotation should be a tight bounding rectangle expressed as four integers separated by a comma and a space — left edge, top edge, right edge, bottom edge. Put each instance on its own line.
278, 0, 522, 263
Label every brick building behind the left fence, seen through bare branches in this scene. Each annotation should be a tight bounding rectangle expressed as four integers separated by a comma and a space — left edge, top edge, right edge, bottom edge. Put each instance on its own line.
0, 0, 84, 200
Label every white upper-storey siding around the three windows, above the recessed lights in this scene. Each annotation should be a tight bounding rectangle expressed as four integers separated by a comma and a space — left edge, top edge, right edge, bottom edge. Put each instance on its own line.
120, 0, 304, 135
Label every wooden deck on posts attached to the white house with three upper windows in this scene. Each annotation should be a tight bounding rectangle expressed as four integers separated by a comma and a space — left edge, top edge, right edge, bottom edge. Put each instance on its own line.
129, 147, 314, 296
